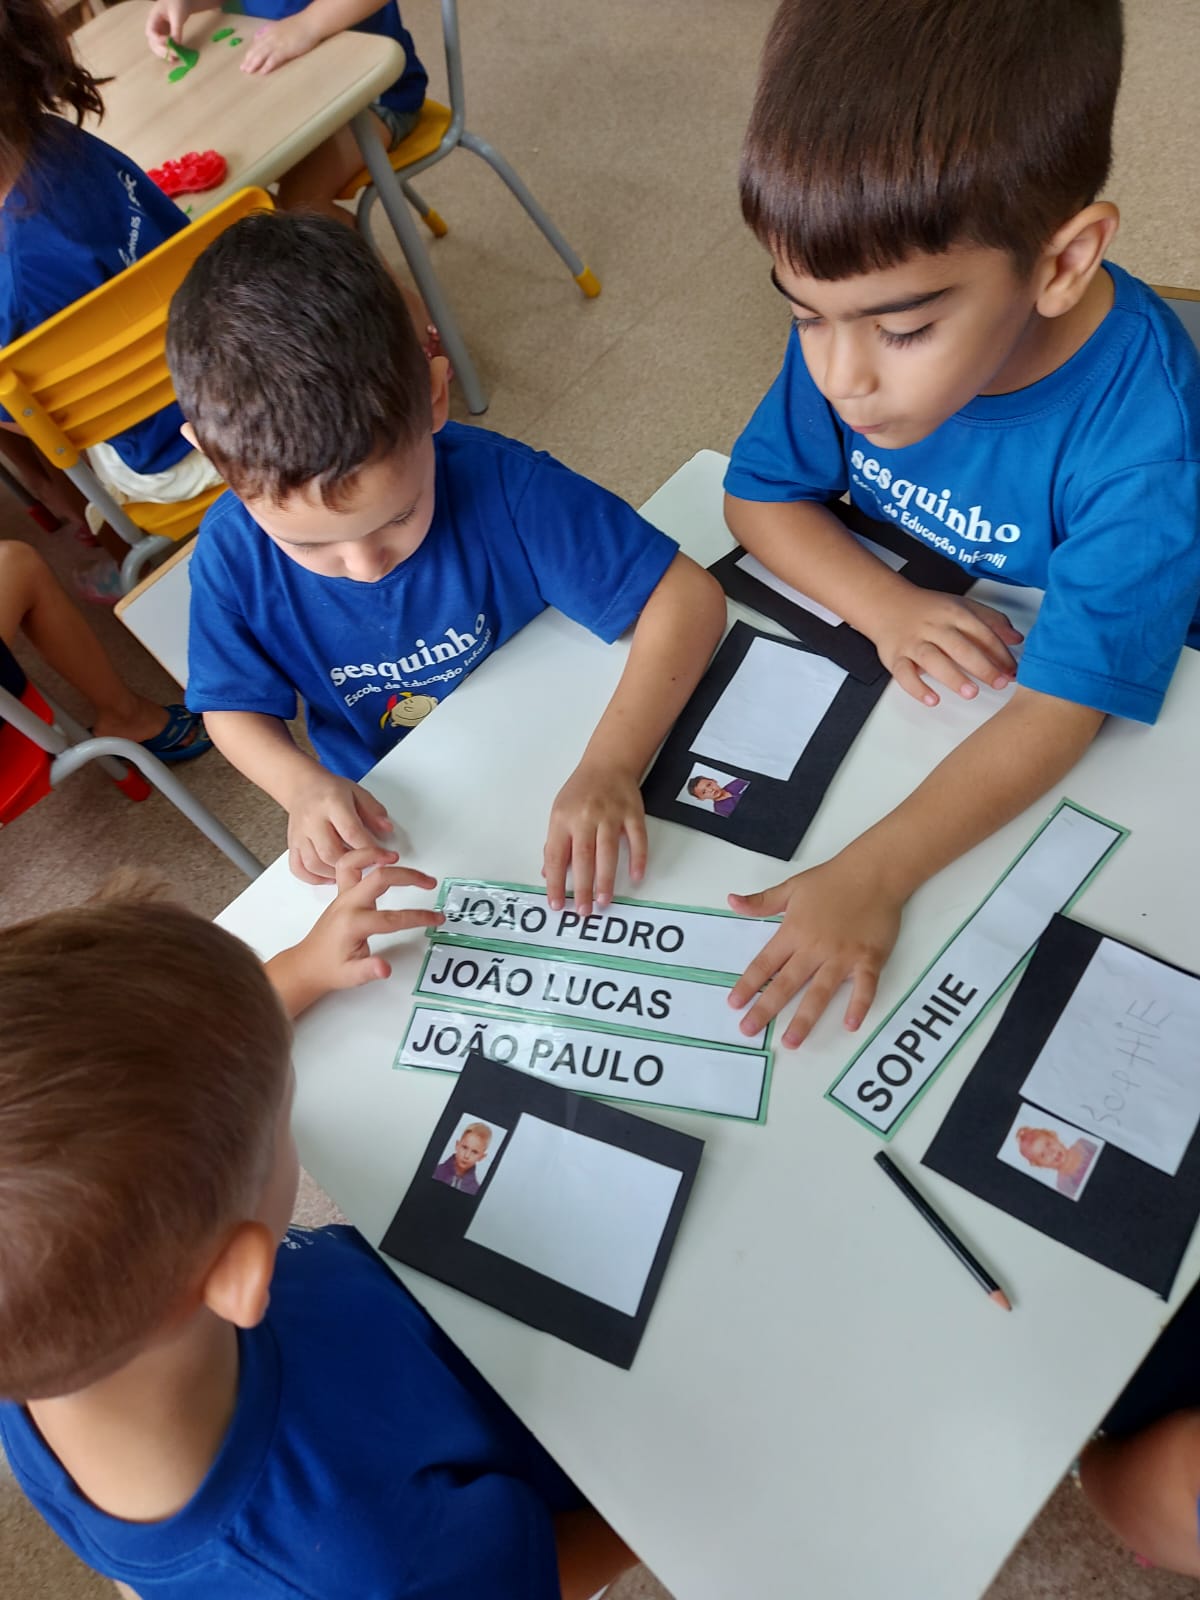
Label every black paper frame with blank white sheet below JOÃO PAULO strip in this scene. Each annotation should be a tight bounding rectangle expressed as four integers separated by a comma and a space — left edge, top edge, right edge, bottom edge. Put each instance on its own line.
379, 1051, 704, 1368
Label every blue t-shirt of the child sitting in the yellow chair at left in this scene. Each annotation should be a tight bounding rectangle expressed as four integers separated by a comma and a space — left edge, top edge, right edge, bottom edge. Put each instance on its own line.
0, 117, 192, 472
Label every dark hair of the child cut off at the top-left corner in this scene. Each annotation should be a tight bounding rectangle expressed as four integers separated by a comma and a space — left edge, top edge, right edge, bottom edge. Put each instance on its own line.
0, 0, 107, 195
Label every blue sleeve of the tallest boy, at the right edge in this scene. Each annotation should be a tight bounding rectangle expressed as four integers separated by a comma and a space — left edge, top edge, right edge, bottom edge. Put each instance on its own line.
1018, 461, 1200, 722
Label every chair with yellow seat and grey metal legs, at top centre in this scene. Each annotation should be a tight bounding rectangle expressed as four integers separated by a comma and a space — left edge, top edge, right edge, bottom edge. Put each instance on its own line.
338, 0, 600, 414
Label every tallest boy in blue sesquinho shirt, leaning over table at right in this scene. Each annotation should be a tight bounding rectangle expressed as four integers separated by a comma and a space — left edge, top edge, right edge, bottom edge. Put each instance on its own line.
725, 0, 1200, 1046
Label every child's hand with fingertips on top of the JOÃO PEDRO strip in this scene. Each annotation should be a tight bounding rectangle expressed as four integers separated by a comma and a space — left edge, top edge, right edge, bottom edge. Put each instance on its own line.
542, 763, 646, 917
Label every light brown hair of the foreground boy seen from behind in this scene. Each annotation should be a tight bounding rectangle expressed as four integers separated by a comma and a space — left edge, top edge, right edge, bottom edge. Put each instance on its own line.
0, 901, 291, 1400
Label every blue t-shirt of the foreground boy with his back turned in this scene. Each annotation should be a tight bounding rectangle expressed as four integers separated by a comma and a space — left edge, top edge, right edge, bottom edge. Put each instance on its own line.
0, 1227, 584, 1600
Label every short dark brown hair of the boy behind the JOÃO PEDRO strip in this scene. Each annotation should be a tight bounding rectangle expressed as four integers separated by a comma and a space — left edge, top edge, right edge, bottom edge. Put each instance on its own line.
166, 211, 432, 507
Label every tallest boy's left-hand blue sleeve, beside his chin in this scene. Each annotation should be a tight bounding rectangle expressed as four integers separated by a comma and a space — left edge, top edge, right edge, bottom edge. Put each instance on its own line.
725, 333, 850, 501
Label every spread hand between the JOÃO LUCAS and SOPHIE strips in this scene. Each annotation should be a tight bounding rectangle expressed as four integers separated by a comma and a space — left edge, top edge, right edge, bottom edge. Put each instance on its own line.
730, 856, 904, 1050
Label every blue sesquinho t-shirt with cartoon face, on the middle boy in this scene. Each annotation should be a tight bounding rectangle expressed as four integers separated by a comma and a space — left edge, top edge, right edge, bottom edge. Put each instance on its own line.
187, 422, 678, 778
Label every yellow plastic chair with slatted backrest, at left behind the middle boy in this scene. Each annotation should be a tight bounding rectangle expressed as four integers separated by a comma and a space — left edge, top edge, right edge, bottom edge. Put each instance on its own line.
0, 189, 272, 592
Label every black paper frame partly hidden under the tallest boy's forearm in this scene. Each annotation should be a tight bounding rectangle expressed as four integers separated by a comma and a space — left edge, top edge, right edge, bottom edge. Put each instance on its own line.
709, 501, 976, 683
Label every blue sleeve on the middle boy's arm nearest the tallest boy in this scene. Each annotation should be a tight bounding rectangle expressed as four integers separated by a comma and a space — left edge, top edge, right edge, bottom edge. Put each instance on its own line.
512, 456, 678, 645
